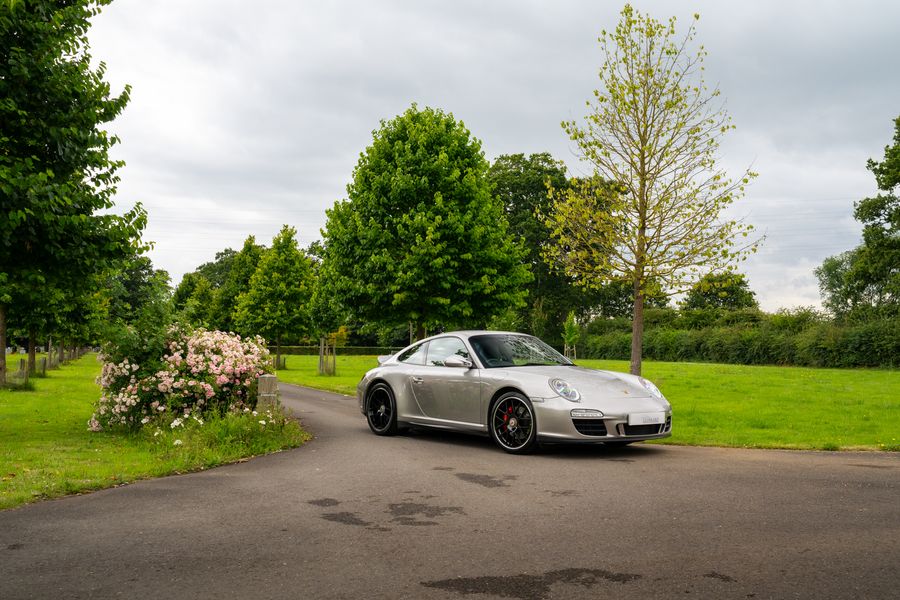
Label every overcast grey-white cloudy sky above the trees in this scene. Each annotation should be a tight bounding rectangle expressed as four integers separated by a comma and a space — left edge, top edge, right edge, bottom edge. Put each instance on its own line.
90, 0, 900, 310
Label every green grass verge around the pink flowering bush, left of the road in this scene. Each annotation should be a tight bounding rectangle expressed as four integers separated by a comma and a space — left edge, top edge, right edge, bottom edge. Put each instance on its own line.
0, 354, 309, 509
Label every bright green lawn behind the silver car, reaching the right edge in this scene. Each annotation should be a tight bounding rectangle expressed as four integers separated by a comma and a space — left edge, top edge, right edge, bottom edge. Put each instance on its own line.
278, 356, 900, 451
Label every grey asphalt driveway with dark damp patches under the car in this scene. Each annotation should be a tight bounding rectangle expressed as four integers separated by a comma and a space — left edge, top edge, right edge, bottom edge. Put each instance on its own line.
0, 385, 900, 600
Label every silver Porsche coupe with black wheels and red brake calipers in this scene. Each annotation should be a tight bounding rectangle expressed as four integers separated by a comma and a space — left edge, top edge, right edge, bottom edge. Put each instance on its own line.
356, 331, 672, 454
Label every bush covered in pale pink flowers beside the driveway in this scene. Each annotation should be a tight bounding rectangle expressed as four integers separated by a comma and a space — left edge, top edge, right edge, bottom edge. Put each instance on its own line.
88, 329, 269, 431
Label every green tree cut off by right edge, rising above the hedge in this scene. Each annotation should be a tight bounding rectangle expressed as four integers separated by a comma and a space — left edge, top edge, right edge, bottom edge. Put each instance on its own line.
815, 117, 900, 318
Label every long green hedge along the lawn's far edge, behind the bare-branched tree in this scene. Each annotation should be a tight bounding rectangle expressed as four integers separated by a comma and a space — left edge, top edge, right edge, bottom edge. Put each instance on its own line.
578, 308, 900, 368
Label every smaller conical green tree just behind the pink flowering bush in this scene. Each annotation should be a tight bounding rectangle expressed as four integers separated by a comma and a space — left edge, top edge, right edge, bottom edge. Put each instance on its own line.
235, 225, 314, 364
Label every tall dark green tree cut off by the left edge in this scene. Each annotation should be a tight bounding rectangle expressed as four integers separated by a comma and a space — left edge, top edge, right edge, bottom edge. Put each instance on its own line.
0, 0, 146, 384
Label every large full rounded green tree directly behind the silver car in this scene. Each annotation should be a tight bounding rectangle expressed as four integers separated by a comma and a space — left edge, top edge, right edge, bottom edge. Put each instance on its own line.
322, 105, 530, 338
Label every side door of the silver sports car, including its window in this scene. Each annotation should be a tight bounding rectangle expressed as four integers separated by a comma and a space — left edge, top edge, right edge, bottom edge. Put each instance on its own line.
412, 336, 481, 426
